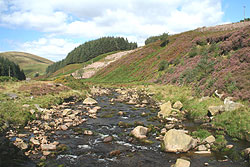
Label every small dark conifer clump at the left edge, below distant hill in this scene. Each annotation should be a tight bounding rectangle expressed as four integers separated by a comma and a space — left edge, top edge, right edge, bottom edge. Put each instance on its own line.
0, 57, 26, 80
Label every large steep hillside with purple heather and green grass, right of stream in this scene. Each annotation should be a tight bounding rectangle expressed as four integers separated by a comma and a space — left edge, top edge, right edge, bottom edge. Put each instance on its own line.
90, 23, 250, 100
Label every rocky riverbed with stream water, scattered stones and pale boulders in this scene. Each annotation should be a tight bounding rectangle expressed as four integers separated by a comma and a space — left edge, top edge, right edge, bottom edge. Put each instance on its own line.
0, 88, 250, 167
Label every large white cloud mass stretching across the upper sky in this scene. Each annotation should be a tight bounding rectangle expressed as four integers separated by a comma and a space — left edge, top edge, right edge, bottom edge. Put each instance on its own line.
0, 0, 223, 60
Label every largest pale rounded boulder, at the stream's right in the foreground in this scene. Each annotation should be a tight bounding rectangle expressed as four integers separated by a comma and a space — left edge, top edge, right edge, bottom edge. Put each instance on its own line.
163, 129, 197, 152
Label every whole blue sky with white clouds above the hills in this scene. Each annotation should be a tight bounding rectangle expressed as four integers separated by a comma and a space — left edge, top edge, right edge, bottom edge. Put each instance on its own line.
0, 0, 250, 61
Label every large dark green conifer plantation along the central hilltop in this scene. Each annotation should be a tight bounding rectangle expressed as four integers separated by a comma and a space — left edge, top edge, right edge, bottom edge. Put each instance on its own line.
46, 37, 137, 73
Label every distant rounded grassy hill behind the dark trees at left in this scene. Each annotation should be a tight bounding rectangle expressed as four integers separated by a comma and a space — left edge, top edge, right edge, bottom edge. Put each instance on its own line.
0, 52, 53, 77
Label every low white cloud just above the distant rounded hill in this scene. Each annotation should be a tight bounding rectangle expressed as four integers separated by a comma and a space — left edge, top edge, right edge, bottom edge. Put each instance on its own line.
18, 38, 79, 61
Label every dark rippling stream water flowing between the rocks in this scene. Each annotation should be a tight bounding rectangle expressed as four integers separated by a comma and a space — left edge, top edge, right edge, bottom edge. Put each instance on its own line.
0, 92, 250, 167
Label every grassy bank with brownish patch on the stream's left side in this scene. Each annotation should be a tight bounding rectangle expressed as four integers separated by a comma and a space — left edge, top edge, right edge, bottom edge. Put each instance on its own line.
0, 78, 87, 132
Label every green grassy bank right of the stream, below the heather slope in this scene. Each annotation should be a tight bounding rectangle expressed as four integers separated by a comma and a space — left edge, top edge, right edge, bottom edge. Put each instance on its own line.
148, 85, 250, 141
